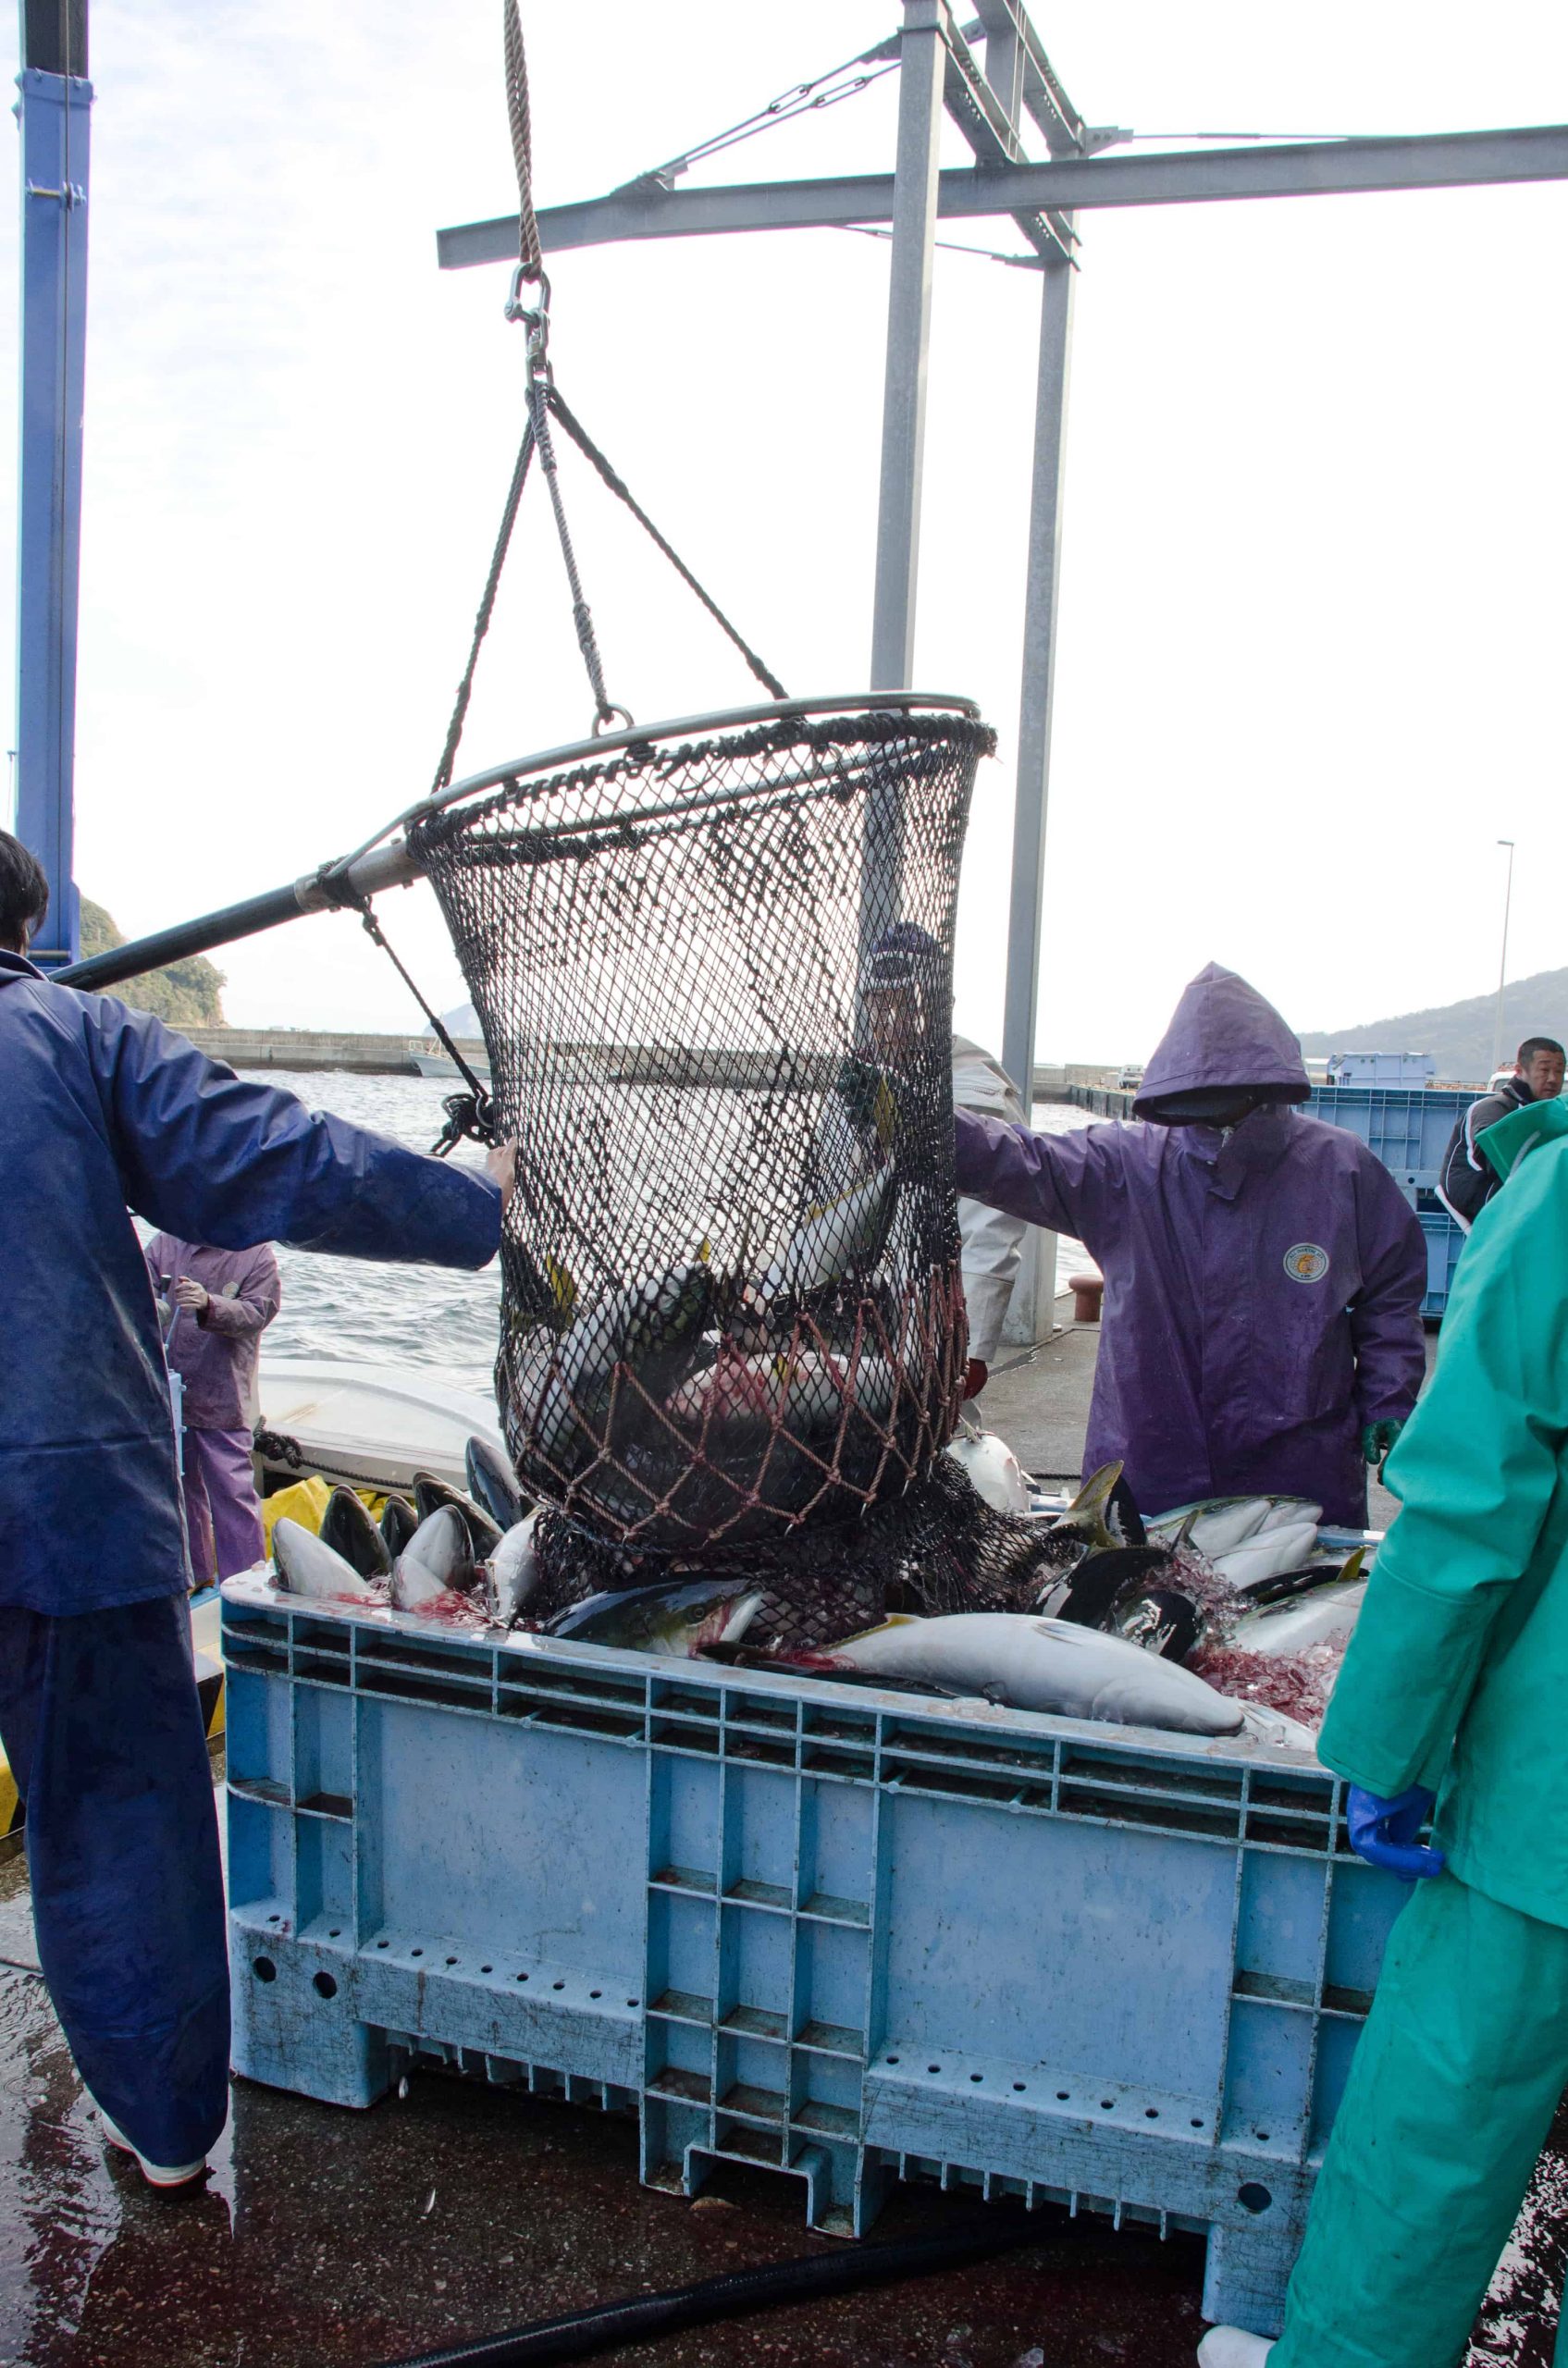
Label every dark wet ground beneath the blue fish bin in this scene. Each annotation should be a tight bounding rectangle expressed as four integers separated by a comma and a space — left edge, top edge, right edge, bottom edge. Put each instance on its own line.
0, 1819, 1568, 2368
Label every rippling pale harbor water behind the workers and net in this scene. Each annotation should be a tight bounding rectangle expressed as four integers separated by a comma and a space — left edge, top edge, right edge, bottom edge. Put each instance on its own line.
254, 1070, 1085, 1395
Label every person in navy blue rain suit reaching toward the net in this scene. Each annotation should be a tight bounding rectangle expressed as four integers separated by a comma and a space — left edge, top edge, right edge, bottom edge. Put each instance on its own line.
0, 832, 514, 2188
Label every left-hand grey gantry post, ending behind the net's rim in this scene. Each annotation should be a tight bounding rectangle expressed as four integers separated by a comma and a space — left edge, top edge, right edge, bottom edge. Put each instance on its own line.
871, 0, 947, 692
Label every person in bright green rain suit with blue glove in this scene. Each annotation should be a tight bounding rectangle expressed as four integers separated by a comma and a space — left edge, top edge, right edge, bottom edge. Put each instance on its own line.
1199, 1104, 1568, 2368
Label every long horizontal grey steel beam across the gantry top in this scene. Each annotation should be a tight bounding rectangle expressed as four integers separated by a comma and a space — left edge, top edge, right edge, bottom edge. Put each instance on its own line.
436, 123, 1568, 270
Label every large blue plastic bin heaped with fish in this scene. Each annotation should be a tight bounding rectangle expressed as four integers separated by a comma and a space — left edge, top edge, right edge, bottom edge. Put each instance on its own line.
223, 1574, 1404, 2333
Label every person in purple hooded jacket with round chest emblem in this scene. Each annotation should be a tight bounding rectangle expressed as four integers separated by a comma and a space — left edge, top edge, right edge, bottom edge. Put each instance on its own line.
957, 964, 1426, 1527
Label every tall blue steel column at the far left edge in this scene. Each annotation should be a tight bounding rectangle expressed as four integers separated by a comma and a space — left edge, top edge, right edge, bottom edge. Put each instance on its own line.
17, 67, 93, 968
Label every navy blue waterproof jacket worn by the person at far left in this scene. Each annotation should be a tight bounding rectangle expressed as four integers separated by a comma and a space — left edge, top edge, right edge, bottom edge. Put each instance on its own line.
0, 950, 500, 1612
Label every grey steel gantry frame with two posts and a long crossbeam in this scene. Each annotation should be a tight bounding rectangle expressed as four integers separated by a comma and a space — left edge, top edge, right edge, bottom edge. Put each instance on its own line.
436, 0, 1568, 1340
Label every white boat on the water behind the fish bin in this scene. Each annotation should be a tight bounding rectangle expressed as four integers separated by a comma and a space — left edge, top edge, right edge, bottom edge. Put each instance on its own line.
258, 1354, 504, 1489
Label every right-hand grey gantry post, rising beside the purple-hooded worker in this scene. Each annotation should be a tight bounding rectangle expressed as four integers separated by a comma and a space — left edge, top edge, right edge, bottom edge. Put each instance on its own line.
1002, 244, 1078, 1343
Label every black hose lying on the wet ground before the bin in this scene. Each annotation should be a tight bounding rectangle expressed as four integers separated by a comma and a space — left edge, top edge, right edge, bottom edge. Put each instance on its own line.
386, 2209, 1151, 2368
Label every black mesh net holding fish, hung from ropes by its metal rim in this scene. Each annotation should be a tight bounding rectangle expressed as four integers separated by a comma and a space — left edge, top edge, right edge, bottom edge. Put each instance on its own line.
410, 692, 994, 1558
